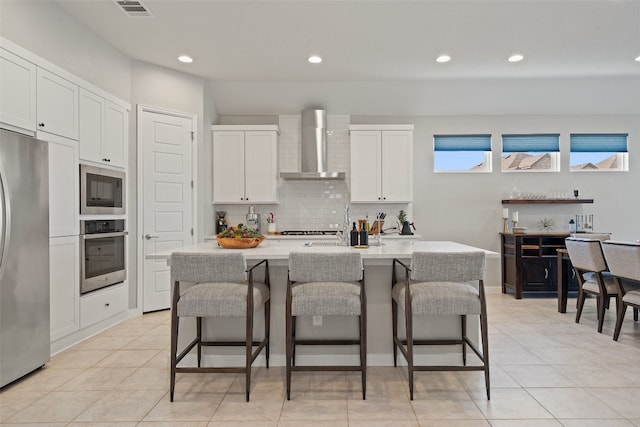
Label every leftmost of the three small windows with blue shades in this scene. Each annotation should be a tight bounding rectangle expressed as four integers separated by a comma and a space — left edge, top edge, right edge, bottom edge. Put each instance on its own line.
433, 134, 491, 172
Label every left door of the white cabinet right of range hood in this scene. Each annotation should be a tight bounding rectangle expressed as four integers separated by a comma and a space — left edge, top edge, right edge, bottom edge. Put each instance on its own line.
351, 131, 382, 202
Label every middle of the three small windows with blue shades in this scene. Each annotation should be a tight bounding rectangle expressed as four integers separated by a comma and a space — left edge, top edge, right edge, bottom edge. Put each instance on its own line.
501, 133, 560, 172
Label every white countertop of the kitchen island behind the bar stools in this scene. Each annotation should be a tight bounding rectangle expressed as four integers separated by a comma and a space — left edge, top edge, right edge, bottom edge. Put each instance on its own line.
146, 236, 499, 262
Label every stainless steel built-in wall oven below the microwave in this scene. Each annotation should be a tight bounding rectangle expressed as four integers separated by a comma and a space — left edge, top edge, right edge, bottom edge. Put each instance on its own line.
80, 219, 127, 294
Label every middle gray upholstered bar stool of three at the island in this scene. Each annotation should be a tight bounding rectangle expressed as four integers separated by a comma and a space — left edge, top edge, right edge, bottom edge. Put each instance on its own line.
286, 252, 367, 400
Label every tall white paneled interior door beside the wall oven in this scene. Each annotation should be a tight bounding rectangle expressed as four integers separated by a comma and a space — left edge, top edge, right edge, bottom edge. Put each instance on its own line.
139, 111, 195, 312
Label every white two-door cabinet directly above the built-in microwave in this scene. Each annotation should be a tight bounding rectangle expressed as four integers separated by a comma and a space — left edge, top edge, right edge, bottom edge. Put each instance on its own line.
79, 89, 128, 167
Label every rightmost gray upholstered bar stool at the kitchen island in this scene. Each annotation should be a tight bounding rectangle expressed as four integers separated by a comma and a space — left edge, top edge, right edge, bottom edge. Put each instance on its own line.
391, 251, 491, 400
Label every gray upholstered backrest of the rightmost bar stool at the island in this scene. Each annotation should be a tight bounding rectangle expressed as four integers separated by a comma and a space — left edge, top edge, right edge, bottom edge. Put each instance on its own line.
411, 251, 485, 282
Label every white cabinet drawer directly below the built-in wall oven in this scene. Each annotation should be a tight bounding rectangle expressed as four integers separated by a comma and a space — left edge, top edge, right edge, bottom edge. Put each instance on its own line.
80, 282, 128, 328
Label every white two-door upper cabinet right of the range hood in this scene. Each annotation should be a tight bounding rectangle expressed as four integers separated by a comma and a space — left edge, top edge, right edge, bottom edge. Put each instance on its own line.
349, 125, 413, 203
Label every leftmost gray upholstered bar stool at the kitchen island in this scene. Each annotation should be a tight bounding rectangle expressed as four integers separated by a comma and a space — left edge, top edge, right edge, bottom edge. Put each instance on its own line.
169, 252, 270, 402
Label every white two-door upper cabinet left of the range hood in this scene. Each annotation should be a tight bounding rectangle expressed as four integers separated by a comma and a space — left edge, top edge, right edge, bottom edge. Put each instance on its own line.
212, 125, 278, 204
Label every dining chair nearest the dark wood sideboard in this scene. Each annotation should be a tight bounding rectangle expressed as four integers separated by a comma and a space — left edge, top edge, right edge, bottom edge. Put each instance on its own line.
565, 237, 618, 332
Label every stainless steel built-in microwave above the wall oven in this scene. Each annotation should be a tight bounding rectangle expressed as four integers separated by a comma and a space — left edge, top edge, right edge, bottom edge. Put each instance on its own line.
80, 165, 126, 215
